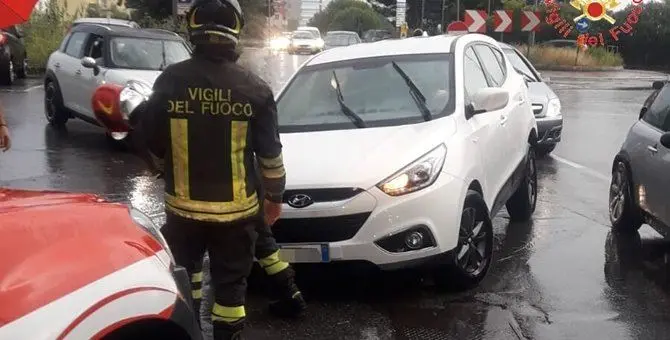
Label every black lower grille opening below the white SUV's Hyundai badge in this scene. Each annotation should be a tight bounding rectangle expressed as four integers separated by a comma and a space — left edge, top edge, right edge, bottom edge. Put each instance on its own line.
272, 212, 370, 243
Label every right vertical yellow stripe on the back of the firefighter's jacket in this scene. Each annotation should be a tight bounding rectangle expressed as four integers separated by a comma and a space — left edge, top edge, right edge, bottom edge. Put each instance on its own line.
230, 120, 249, 202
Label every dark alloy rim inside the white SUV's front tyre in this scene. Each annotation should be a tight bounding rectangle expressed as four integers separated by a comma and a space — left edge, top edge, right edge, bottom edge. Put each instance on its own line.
456, 208, 488, 277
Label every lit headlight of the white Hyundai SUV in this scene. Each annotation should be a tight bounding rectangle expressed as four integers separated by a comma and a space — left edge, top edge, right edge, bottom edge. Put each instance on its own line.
377, 144, 447, 196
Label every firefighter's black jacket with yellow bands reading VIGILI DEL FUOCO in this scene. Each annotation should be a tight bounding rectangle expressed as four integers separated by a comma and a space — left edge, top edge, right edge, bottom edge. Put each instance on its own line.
140, 55, 286, 222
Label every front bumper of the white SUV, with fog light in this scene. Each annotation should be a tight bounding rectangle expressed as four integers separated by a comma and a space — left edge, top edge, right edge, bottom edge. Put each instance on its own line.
272, 173, 467, 269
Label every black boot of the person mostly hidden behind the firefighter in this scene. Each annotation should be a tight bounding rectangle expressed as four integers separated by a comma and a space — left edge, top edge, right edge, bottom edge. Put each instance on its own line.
269, 267, 307, 318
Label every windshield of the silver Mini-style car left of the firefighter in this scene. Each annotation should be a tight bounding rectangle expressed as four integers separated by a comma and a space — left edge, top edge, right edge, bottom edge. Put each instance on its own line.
110, 37, 191, 70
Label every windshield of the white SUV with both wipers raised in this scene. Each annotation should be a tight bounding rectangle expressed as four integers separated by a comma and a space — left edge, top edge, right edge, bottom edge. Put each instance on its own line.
277, 54, 454, 132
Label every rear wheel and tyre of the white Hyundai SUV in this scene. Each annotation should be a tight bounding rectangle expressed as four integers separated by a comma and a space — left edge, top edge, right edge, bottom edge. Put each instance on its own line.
505, 145, 537, 222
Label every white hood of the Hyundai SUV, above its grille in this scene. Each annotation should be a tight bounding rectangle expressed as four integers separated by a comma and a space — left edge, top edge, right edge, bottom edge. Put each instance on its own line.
281, 117, 456, 189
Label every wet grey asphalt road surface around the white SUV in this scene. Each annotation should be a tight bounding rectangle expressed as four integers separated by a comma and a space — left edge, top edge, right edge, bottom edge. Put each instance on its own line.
0, 50, 670, 340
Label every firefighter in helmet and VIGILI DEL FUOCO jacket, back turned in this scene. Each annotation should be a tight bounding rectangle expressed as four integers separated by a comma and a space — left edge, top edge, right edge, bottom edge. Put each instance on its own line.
136, 0, 304, 340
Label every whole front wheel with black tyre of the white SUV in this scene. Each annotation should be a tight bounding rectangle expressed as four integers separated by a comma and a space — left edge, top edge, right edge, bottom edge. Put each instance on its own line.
433, 190, 493, 291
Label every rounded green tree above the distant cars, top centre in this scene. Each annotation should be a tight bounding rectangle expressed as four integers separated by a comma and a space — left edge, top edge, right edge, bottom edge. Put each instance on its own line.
308, 0, 393, 35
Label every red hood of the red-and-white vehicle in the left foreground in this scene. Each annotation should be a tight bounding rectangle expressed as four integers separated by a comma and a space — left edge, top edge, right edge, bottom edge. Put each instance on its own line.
0, 188, 162, 327
